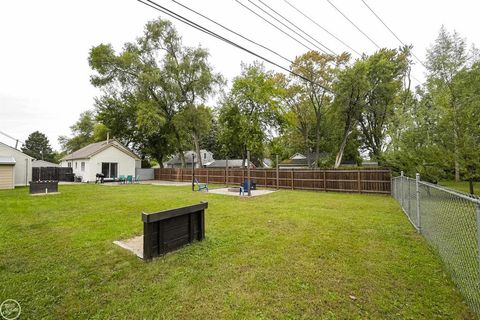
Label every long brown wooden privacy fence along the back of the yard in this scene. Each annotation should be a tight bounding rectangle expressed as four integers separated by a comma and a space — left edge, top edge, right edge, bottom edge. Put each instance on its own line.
154, 168, 391, 194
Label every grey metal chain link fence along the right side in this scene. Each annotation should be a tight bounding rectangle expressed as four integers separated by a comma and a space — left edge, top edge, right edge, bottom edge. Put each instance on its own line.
392, 174, 480, 318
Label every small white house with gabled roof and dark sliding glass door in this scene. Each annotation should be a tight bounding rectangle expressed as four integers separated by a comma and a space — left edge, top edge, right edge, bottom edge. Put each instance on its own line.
60, 139, 141, 182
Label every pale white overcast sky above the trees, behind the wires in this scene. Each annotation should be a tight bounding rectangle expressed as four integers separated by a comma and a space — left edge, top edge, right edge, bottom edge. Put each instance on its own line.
0, 0, 480, 149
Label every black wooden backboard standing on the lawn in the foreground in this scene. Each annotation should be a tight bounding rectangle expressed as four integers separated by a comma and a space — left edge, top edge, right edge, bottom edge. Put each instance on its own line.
142, 202, 208, 260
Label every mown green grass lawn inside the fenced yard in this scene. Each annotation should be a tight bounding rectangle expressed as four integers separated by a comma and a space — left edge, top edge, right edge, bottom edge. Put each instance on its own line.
0, 185, 473, 319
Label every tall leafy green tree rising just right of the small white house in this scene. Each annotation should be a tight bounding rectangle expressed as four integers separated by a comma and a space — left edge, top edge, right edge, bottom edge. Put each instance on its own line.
89, 19, 223, 165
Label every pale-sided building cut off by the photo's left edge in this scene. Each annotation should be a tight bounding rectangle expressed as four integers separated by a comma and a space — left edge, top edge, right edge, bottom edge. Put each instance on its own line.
0, 142, 33, 189
